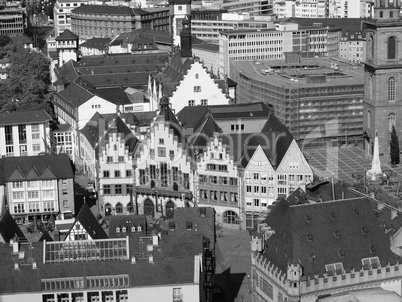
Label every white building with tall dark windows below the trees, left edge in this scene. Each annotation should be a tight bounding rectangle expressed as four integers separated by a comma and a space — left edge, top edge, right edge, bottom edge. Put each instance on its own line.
0, 110, 52, 156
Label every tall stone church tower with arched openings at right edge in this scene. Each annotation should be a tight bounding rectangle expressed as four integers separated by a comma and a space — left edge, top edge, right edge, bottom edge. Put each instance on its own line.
363, 0, 402, 163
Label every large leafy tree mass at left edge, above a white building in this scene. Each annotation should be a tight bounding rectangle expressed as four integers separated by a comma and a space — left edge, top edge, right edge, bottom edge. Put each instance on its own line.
0, 43, 51, 112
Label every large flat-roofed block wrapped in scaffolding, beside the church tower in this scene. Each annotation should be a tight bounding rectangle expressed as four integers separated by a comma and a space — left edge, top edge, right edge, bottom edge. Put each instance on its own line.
230, 55, 364, 147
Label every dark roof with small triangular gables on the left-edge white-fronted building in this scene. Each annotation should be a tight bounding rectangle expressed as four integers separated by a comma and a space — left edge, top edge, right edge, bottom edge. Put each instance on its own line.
0, 154, 74, 181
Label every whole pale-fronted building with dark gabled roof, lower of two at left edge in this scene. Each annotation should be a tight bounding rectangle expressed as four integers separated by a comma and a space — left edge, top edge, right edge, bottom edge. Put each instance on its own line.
1, 154, 74, 223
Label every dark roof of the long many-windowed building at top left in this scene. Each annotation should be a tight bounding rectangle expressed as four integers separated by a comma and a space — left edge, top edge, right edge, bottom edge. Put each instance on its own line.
71, 4, 148, 16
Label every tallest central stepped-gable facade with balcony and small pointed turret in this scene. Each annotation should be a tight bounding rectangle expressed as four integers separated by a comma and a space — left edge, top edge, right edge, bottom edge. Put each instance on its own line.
134, 98, 194, 219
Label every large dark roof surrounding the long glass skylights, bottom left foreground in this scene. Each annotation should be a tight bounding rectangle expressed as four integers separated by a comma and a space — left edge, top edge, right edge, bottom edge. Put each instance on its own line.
0, 234, 203, 294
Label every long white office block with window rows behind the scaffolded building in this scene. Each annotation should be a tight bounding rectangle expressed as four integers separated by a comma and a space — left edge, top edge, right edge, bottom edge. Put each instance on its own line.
219, 21, 341, 77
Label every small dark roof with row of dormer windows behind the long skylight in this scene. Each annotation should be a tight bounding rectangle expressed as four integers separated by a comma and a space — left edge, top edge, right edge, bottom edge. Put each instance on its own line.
108, 214, 147, 238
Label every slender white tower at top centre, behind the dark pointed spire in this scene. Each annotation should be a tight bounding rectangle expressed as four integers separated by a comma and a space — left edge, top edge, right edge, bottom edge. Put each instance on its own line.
169, 0, 191, 47
